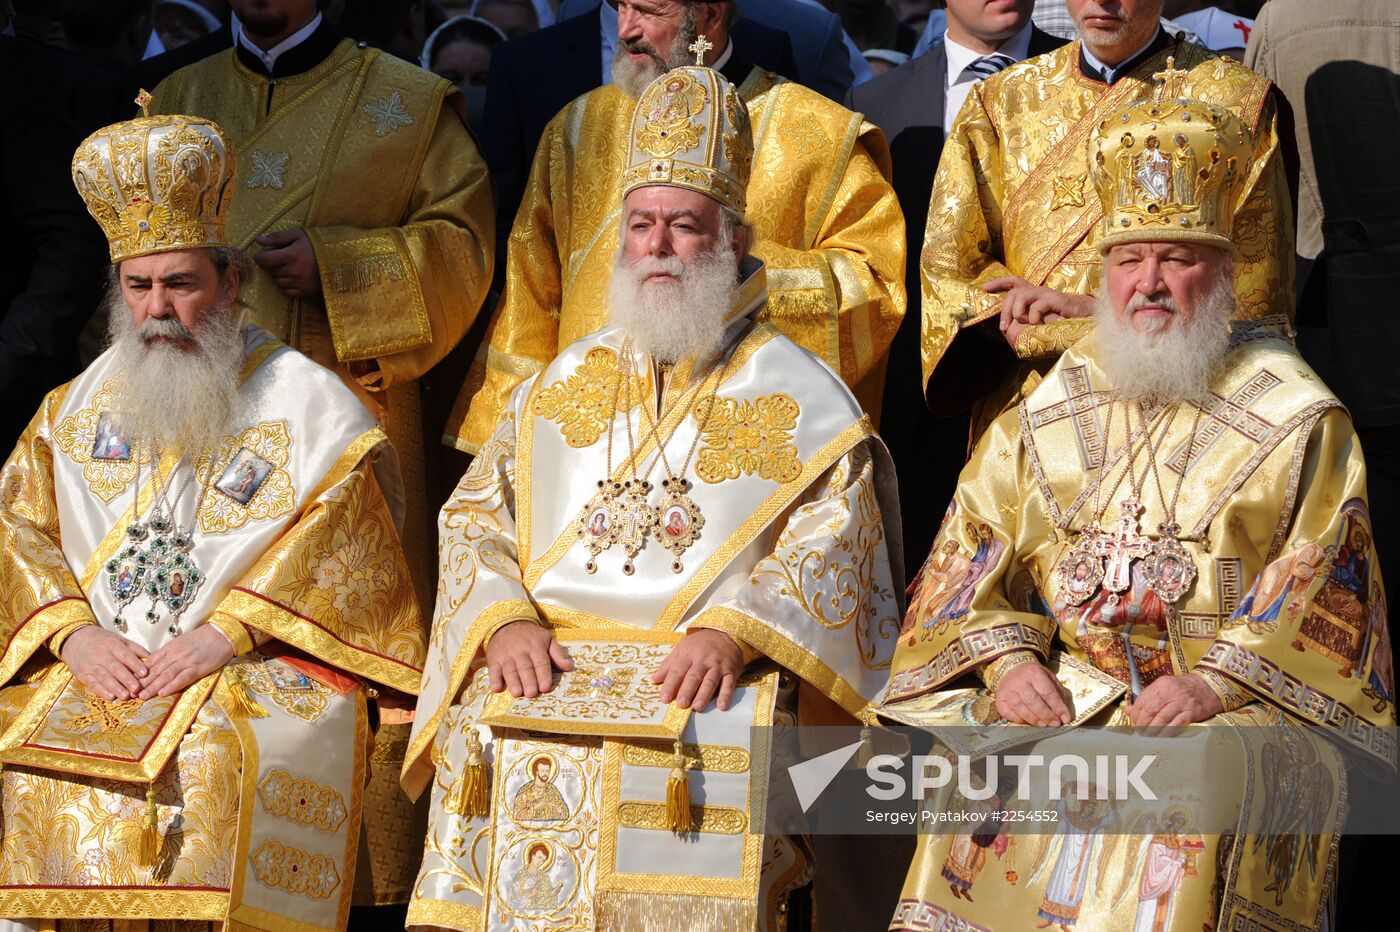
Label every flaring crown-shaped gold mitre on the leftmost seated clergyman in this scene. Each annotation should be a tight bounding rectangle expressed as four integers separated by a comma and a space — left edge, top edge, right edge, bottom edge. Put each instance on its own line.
73, 92, 237, 263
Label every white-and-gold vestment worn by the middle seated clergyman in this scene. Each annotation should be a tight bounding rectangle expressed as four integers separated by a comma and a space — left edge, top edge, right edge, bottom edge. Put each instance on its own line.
405, 263, 902, 932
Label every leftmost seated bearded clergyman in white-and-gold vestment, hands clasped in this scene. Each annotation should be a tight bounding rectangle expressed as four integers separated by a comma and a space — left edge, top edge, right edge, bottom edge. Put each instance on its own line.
0, 116, 424, 932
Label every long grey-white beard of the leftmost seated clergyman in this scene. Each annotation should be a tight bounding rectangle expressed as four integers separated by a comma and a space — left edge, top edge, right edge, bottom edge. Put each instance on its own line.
108, 290, 244, 455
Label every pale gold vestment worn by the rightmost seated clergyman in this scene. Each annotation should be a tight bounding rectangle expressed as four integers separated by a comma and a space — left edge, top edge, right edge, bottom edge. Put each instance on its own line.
886, 318, 1396, 932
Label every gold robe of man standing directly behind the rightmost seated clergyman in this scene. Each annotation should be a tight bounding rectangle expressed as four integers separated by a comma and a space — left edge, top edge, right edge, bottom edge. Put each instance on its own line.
920, 41, 1294, 439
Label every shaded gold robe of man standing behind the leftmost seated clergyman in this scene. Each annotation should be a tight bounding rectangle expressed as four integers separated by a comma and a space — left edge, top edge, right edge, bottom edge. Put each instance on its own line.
151, 39, 496, 616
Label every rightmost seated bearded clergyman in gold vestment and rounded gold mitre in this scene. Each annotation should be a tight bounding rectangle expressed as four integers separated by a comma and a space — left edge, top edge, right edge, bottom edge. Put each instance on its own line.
883, 98, 1396, 932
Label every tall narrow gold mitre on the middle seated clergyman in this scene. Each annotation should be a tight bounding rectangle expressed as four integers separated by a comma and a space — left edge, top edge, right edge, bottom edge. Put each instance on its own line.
622, 58, 753, 216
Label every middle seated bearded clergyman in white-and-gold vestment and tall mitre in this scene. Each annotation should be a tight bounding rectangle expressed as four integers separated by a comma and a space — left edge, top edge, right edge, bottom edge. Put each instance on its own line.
405, 66, 902, 932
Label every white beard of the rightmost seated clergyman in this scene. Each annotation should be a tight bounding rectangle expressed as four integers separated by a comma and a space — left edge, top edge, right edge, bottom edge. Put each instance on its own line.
1093, 274, 1235, 404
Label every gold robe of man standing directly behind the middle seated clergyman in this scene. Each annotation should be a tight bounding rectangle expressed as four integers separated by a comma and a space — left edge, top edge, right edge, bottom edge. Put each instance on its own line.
442, 69, 904, 453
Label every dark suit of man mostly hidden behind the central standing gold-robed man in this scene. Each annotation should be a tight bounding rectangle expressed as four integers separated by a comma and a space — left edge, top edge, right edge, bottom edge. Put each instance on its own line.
482, 6, 797, 284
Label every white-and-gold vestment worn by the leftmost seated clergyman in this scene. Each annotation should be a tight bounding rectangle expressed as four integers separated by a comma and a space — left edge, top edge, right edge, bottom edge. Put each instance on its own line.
0, 329, 424, 932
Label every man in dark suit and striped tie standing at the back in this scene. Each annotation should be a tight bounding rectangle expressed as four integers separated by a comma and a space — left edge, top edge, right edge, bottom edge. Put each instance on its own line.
846, 0, 1064, 575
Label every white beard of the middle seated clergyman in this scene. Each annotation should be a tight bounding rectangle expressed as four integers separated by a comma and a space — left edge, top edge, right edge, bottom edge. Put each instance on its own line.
608, 244, 739, 365
